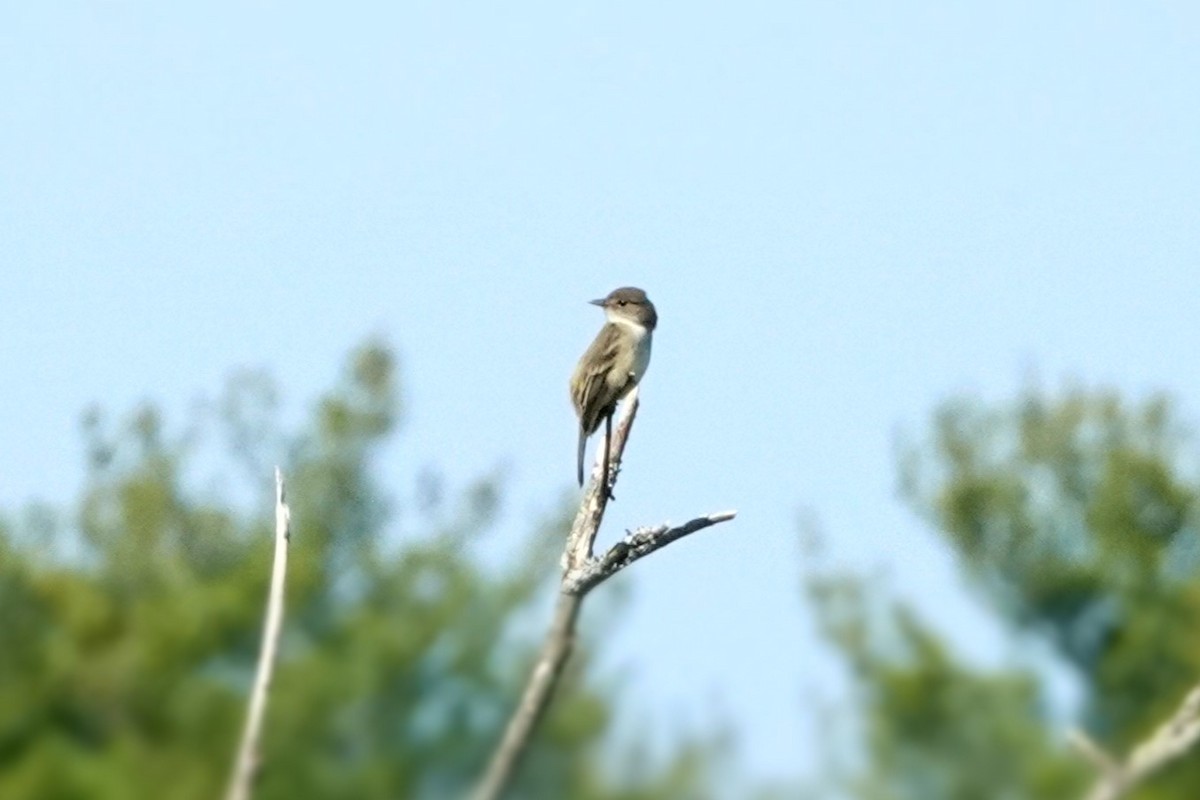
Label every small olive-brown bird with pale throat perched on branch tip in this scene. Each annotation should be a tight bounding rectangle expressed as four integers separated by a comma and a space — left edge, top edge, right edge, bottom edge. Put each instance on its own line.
570, 287, 659, 498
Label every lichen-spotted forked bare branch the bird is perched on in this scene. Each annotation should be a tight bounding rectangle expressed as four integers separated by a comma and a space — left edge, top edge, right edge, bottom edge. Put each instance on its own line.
473, 389, 734, 800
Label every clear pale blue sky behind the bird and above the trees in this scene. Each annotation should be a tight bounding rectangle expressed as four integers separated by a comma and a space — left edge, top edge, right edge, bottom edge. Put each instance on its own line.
0, 1, 1200, 776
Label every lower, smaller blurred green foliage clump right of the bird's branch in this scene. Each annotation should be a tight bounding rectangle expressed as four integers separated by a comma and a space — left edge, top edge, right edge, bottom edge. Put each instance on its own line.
808, 575, 1086, 800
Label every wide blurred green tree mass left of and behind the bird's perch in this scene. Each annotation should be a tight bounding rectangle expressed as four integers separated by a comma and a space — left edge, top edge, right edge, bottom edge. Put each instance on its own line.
0, 344, 719, 800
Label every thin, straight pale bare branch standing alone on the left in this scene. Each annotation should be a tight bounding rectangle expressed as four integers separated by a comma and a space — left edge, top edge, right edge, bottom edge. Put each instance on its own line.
226, 467, 292, 800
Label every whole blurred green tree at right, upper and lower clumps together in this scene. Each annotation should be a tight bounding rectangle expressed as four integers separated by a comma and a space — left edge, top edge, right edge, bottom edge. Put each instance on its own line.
808, 390, 1200, 800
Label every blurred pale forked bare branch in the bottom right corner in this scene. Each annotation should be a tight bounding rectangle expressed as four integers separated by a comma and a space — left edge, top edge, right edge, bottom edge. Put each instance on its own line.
1072, 686, 1200, 800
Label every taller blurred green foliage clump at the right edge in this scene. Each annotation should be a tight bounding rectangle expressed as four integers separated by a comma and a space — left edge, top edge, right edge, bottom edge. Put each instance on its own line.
906, 391, 1200, 753
